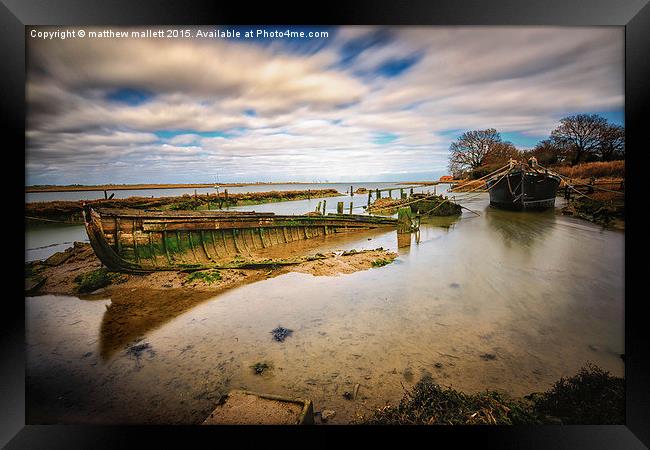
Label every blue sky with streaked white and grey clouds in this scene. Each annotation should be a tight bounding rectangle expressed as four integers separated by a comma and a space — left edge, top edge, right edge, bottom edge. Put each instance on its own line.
26, 27, 624, 184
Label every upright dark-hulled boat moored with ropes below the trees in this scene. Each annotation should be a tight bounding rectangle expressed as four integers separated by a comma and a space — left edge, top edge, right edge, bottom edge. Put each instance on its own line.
487, 158, 561, 210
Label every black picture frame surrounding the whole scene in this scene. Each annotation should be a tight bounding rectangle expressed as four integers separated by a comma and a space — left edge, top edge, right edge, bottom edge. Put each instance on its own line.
0, 0, 650, 449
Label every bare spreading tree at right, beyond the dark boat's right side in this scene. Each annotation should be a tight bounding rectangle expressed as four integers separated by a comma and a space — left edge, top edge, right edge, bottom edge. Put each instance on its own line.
551, 114, 608, 165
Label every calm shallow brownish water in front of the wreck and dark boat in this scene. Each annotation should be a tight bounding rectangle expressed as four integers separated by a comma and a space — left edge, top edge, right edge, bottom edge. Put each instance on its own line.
26, 194, 625, 423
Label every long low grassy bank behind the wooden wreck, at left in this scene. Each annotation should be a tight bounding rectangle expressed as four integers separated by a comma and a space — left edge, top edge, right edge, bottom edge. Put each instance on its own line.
25, 189, 339, 223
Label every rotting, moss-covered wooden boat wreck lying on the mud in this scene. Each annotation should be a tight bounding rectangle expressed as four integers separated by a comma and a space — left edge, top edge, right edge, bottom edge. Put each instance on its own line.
83, 205, 397, 273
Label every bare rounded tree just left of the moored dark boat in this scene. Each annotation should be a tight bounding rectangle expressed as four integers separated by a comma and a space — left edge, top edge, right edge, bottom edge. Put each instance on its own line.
449, 128, 504, 175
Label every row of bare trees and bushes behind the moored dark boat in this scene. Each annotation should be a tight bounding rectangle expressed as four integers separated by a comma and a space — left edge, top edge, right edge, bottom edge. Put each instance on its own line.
449, 114, 625, 178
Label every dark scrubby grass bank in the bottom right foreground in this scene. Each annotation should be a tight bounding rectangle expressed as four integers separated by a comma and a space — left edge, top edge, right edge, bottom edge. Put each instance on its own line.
361, 364, 625, 425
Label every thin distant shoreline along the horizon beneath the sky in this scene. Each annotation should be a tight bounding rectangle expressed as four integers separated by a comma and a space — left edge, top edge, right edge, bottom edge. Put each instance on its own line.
25, 181, 438, 193
